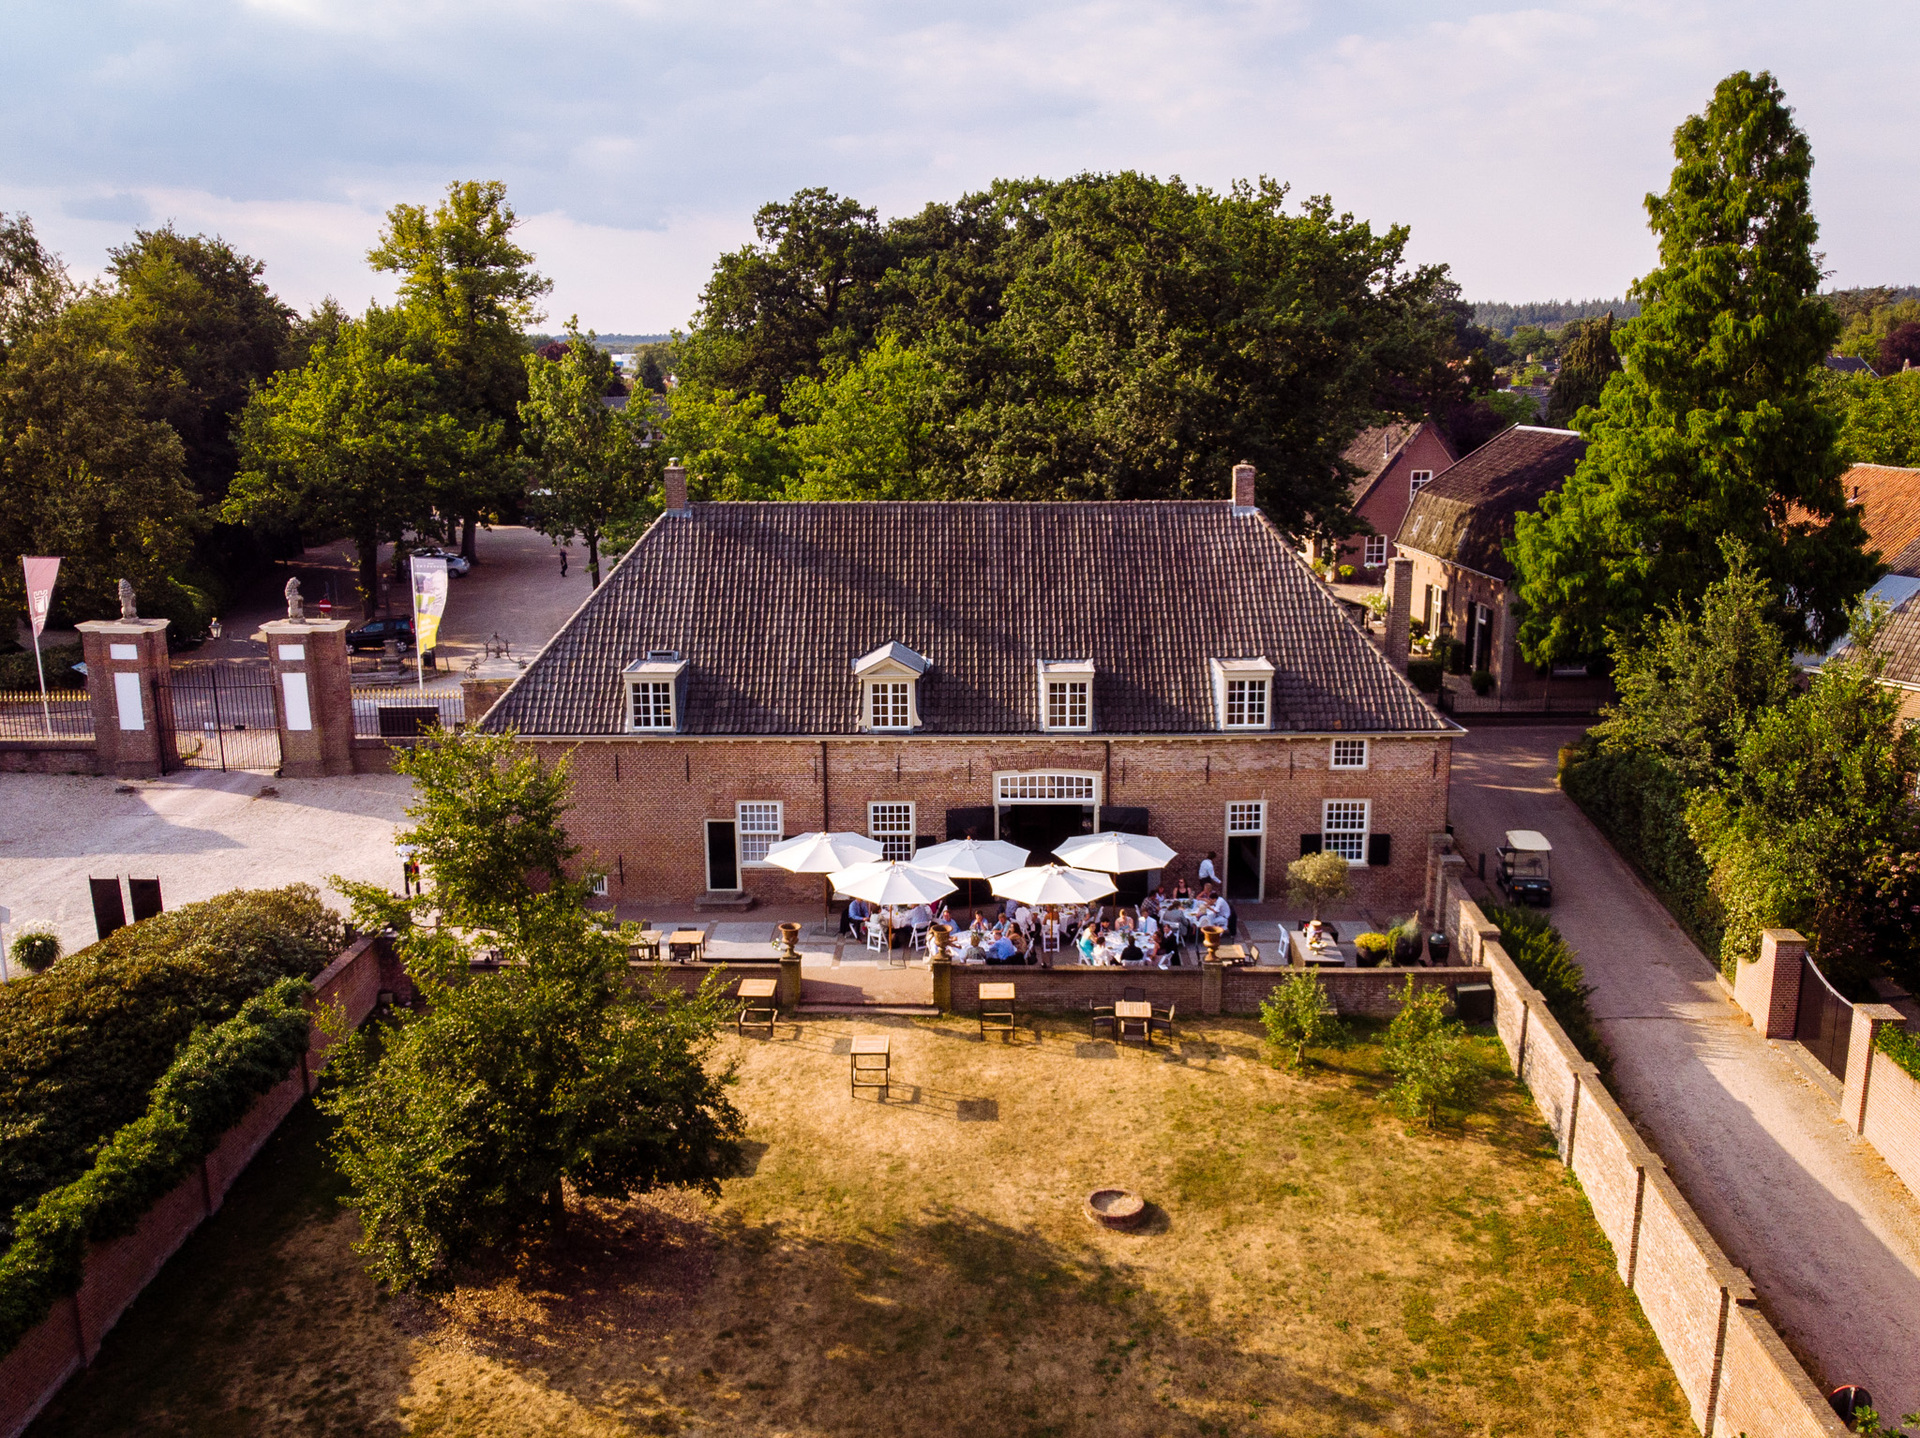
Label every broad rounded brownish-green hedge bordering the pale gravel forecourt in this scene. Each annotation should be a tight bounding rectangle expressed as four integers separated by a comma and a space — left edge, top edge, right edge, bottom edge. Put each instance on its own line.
0, 885, 344, 1244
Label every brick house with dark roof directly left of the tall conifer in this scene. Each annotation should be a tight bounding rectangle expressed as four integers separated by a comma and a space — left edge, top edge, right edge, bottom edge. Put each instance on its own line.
1394, 424, 1586, 697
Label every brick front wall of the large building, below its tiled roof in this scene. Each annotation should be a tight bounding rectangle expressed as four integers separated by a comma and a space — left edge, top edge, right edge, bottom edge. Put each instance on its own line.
534, 735, 1452, 910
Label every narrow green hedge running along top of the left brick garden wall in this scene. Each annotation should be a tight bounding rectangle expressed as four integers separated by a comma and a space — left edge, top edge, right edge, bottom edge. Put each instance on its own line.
0, 979, 311, 1352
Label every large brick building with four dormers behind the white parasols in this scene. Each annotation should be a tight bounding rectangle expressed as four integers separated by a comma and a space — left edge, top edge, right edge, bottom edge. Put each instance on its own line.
482, 465, 1457, 914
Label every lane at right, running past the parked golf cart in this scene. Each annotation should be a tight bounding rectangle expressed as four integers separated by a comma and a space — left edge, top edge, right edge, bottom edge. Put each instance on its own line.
1452, 728, 1920, 1417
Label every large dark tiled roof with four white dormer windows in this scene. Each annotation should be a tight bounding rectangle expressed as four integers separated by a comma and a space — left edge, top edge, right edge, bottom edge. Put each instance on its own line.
484, 501, 1450, 735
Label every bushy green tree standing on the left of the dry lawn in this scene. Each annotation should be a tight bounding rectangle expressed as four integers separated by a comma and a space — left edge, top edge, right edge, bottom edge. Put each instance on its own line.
323, 735, 743, 1288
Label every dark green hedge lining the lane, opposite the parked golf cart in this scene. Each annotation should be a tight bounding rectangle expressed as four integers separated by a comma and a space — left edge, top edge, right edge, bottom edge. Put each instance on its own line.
1561, 751, 1726, 956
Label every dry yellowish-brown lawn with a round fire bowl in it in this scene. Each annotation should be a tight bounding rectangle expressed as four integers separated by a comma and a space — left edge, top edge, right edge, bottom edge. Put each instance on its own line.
33, 1018, 1692, 1438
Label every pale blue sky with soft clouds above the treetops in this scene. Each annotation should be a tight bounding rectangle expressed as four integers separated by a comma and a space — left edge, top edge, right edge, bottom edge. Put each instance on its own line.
0, 0, 1920, 334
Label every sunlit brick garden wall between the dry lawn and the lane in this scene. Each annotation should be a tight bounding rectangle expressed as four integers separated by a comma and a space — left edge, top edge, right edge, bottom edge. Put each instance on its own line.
1440, 875, 1845, 1438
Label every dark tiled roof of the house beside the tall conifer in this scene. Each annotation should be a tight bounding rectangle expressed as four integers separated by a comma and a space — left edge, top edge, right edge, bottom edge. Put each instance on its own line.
1394, 424, 1586, 580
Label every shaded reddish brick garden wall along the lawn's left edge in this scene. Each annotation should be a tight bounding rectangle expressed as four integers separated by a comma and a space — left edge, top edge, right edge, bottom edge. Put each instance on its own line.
0, 937, 395, 1438
